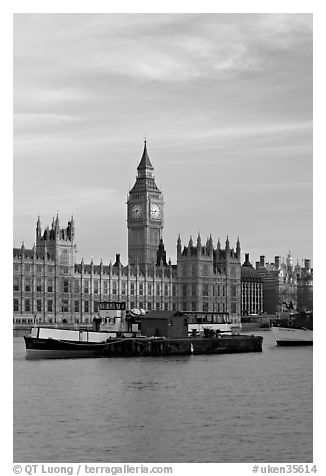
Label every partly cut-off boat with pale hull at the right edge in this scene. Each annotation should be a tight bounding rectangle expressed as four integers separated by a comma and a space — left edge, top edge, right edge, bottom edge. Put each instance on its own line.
272, 311, 313, 346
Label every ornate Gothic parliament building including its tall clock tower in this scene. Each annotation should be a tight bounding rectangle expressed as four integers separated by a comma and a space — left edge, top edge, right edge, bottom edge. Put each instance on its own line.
13, 141, 241, 324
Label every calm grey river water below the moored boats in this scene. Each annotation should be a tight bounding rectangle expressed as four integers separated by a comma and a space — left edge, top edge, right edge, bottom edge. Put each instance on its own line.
13, 331, 313, 463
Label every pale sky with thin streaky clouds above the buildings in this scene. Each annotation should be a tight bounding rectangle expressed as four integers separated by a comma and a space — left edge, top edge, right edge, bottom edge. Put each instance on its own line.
13, 13, 313, 264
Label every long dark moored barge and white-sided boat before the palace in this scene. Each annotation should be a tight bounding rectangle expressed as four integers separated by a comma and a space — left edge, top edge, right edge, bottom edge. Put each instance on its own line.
24, 302, 263, 359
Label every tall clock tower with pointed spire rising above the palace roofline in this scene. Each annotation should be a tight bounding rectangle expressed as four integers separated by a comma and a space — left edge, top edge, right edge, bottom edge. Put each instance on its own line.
127, 140, 163, 267
